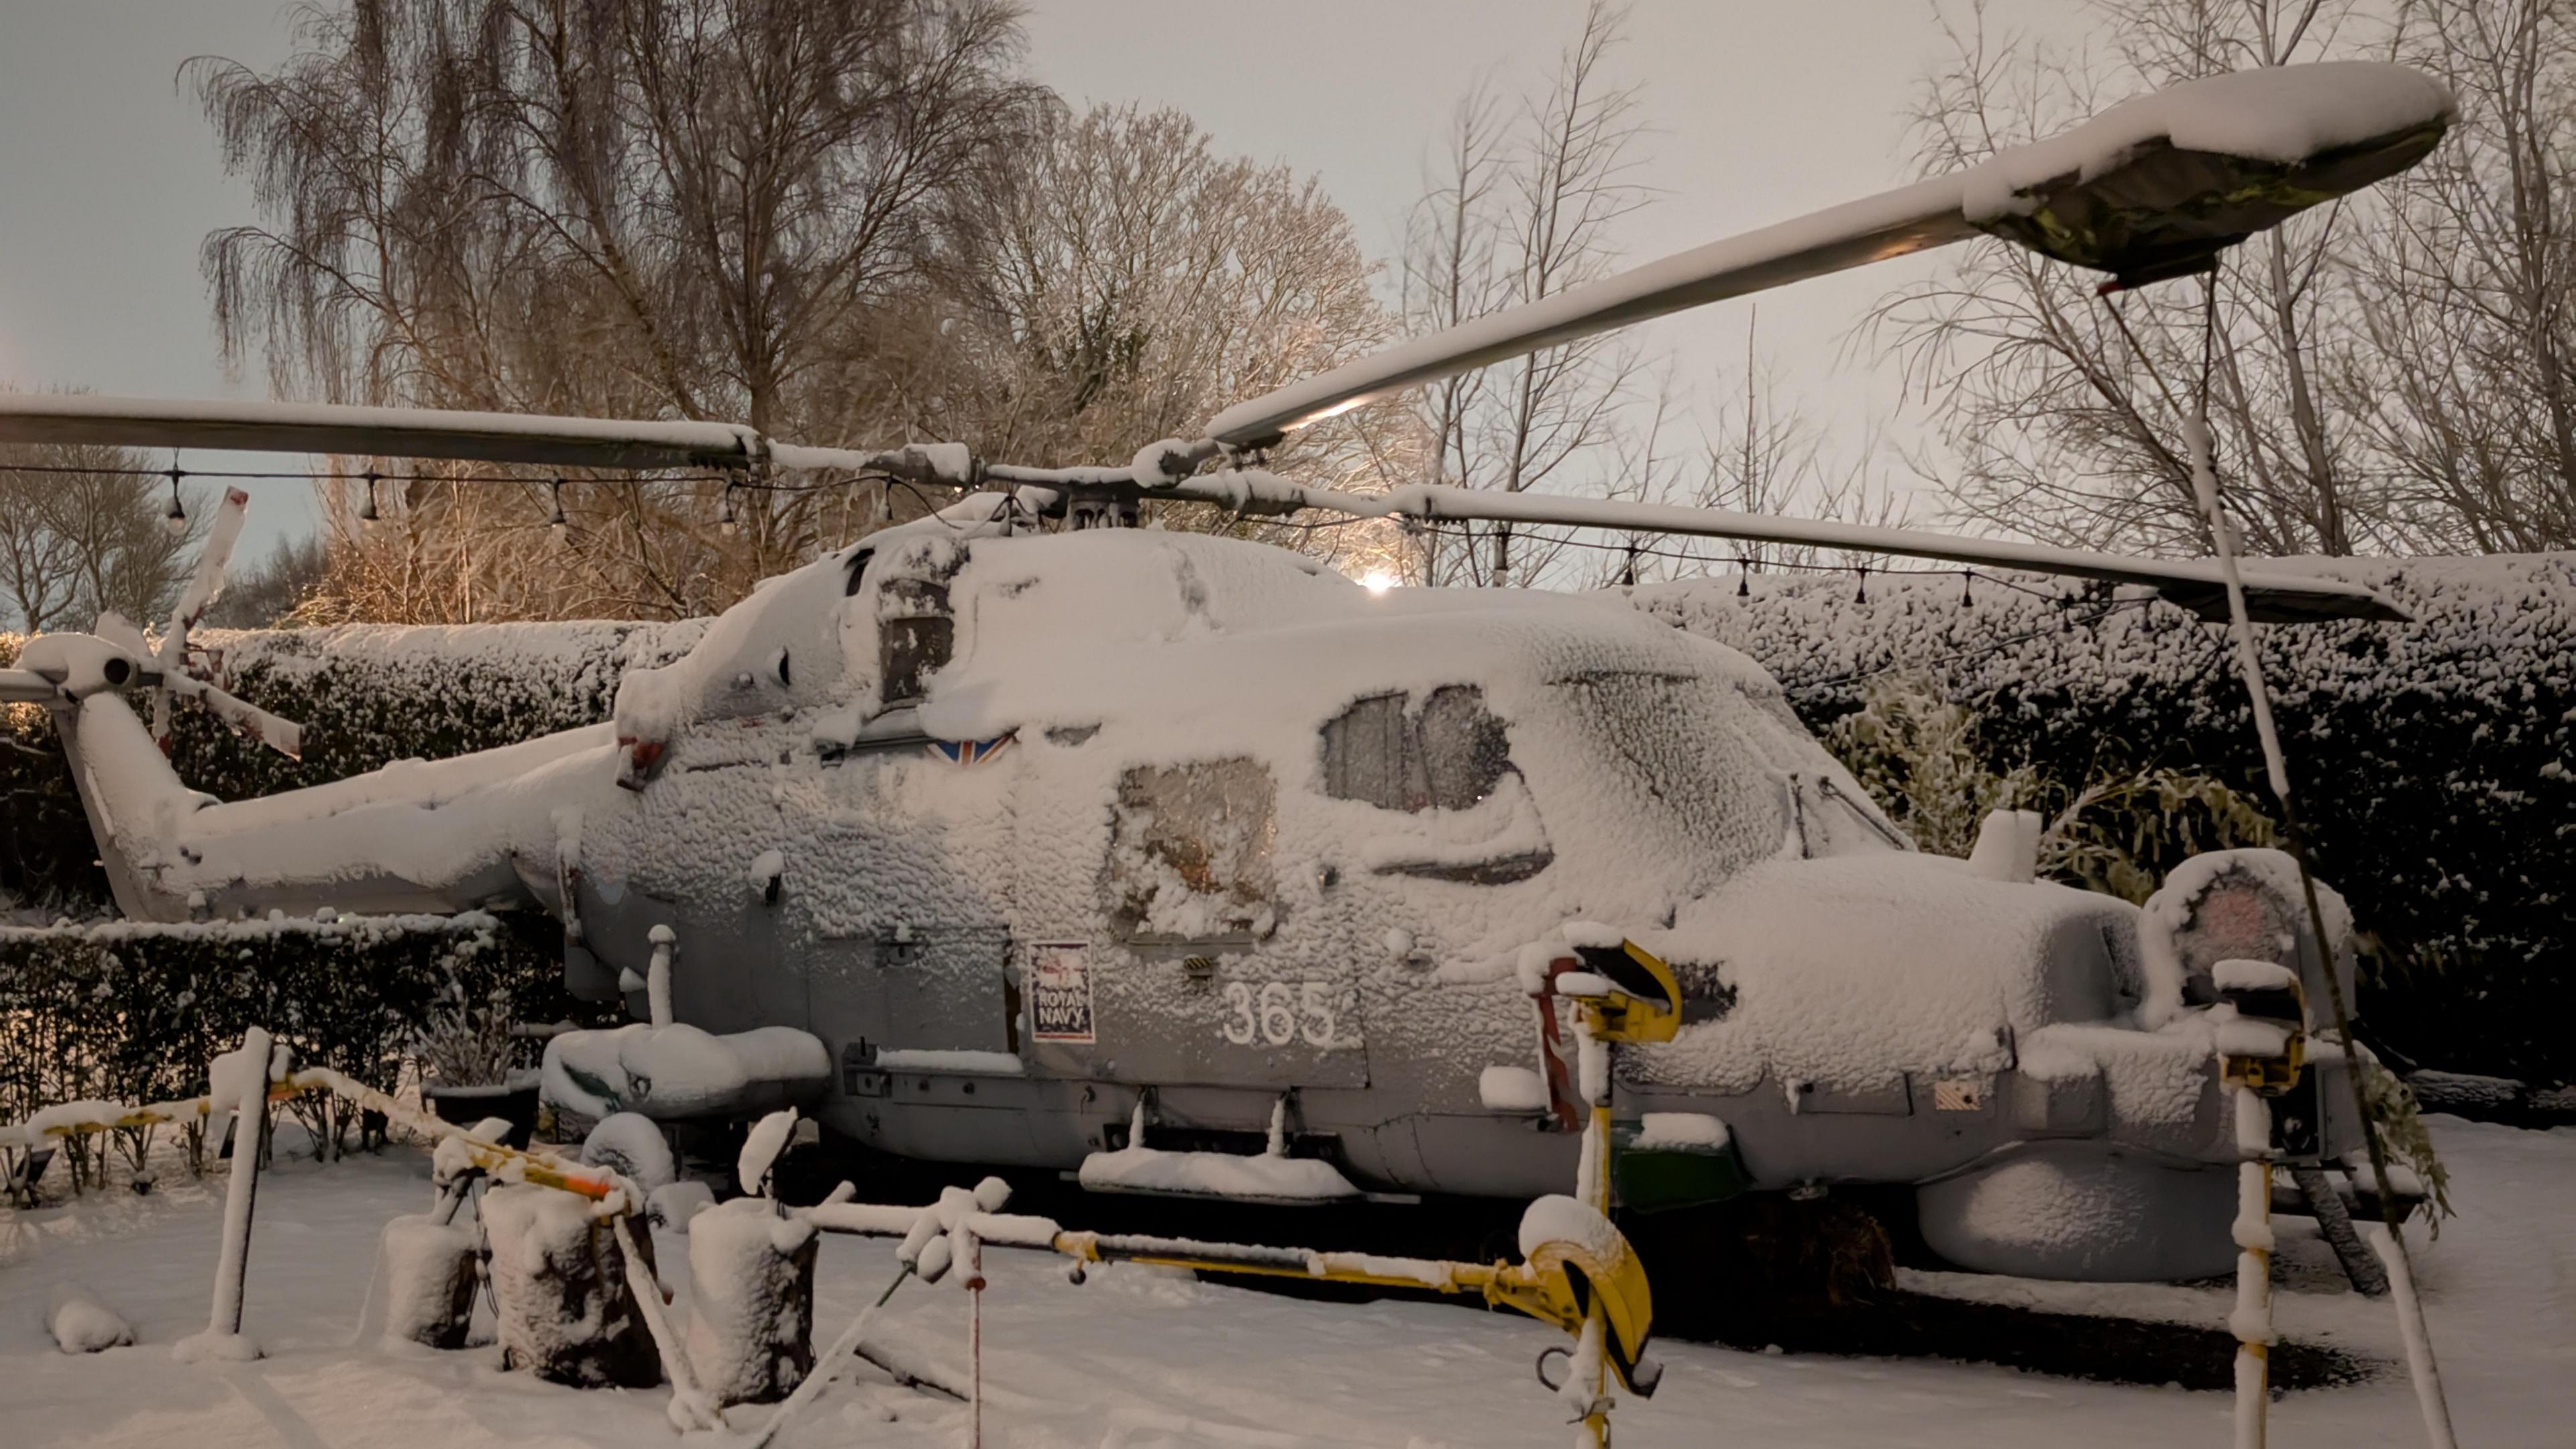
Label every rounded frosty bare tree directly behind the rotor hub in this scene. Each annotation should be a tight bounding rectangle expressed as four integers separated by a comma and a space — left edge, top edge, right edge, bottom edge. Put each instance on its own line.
937, 106, 1393, 485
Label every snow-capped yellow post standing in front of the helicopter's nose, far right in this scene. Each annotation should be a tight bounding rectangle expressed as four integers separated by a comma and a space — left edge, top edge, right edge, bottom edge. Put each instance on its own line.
2210, 962, 2306, 1449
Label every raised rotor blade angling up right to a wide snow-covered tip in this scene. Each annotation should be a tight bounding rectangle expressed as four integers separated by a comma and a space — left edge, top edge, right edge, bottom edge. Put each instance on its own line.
1208, 62, 2455, 449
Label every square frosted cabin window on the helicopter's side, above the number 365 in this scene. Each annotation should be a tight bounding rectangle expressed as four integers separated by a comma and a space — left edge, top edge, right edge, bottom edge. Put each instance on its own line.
1105, 758, 1278, 941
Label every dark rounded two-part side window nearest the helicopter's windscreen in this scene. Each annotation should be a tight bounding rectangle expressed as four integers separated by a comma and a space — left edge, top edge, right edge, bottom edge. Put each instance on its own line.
1324, 684, 1512, 812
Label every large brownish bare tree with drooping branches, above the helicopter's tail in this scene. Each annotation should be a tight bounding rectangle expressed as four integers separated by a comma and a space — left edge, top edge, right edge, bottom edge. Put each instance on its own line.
183, 0, 1040, 616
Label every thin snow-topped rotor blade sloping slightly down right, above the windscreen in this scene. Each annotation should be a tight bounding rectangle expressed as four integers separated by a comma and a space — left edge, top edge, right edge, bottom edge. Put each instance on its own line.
1146, 474, 2408, 624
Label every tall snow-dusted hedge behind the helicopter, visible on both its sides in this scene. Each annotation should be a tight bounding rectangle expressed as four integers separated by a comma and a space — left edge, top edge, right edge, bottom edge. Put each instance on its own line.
0, 554, 2576, 1083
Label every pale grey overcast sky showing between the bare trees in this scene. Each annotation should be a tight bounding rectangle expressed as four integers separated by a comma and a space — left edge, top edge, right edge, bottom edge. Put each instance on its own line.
0, 0, 2074, 554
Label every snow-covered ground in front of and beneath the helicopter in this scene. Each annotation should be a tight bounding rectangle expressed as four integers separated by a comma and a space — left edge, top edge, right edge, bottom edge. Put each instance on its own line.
0, 1119, 2576, 1449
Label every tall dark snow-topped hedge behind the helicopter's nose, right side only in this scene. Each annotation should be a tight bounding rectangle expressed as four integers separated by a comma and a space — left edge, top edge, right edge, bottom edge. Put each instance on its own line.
1635, 554, 2576, 1083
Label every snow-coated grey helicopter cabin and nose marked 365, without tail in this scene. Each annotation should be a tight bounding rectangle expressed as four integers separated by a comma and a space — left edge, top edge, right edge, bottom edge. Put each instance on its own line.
553, 531, 2246, 1217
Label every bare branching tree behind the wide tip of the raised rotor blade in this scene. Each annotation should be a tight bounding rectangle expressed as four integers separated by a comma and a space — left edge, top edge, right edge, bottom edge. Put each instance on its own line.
1873, 0, 2401, 554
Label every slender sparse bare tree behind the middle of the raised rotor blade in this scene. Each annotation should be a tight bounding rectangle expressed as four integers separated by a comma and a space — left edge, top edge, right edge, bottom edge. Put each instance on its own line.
1404, 0, 1649, 585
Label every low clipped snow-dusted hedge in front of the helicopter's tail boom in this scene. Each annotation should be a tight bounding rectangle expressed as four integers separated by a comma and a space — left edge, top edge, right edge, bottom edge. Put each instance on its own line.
0, 913, 572, 1122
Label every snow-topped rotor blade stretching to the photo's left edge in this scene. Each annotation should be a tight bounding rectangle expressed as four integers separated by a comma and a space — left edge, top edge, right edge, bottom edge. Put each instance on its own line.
0, 392, 760, 470
